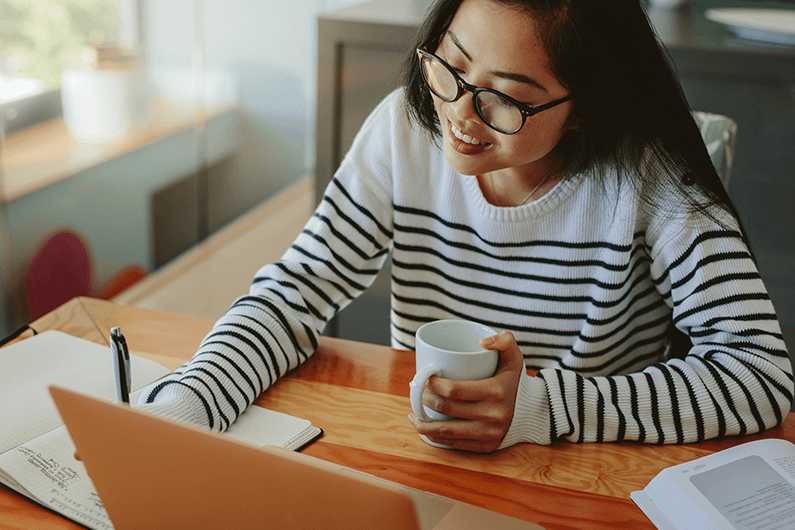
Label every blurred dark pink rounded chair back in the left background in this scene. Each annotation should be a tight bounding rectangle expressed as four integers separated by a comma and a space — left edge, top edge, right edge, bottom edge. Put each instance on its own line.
25, 231, 92, 320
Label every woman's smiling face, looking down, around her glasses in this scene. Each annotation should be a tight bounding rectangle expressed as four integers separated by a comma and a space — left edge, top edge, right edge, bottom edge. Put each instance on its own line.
433, 0, 574, 176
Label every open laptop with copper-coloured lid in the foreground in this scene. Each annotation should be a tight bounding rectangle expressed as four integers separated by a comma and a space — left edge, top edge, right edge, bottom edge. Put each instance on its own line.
50, 386, 541, 530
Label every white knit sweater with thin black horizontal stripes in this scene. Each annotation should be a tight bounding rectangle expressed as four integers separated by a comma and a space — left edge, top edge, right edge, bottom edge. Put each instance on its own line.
139, 91, 793, 447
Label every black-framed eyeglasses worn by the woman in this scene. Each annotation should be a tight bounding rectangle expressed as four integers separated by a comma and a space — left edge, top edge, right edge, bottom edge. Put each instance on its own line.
417, 48, 571, 134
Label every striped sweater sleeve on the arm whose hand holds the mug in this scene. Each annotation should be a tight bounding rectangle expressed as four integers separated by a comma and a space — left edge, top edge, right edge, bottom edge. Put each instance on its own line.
524, 212, 793, 444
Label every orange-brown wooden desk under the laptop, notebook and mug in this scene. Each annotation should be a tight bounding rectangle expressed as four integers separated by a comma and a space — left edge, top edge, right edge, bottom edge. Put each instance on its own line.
0, 298, 795, 530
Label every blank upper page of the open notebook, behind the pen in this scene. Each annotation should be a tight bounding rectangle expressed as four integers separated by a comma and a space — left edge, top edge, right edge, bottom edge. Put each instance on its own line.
0, 331, 170, 454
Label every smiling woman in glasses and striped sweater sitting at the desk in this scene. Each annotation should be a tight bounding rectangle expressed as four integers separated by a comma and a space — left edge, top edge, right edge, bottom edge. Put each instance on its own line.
141, 0, 793, 451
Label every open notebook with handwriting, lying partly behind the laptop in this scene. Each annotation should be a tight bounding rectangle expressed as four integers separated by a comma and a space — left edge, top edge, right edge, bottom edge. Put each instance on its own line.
0, 331, 322, 529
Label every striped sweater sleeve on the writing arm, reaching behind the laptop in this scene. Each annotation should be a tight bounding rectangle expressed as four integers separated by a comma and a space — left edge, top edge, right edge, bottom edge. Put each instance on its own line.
138, 94, 398, 431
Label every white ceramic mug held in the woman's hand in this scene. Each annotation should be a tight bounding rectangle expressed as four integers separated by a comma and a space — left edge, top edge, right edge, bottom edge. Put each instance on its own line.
409, 320, 499, 422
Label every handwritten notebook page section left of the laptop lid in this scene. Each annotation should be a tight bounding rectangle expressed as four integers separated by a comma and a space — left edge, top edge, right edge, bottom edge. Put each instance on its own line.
0, 426, 113, 530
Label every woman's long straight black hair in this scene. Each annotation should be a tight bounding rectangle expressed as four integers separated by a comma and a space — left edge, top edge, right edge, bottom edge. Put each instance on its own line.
404, 0, 747, 237
